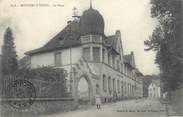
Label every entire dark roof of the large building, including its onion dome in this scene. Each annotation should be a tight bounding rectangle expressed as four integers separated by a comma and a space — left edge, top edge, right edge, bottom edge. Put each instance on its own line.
25, 7, 119, 55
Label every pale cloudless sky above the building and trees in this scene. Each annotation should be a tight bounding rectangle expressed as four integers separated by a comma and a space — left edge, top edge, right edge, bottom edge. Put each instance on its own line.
0, 0, 159, 75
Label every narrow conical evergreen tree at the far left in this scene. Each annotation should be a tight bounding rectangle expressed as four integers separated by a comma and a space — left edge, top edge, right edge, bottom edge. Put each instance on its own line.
2, 27, 18, 75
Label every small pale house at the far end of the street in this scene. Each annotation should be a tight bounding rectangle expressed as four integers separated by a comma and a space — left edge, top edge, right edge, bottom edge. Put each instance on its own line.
148, 80, 161, 98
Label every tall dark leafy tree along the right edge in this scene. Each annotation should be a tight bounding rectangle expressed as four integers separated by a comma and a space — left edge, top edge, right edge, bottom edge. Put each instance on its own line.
144, 0, 183, 92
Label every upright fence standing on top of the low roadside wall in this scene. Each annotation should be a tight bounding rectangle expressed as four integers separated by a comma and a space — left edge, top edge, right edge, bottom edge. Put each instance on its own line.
0, 76, 70, 98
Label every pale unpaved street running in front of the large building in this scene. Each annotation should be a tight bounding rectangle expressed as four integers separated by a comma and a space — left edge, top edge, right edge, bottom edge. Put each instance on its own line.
42, 99, 166, 117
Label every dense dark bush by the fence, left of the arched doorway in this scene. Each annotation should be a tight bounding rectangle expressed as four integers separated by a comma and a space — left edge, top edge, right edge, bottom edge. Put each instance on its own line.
16, 67, 68, 98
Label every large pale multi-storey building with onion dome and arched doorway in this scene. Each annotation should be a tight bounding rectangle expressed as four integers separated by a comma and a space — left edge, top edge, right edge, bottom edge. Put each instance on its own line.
26, 6, 142, 103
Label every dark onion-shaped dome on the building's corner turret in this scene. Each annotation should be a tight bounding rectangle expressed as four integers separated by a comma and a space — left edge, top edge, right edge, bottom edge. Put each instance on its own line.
80, 7, 104, 35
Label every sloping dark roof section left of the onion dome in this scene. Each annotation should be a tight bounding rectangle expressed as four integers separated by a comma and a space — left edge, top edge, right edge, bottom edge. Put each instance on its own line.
25, 21, 81, 55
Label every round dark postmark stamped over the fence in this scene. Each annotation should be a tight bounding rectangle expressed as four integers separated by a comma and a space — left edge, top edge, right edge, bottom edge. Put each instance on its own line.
7, 79, 36, 110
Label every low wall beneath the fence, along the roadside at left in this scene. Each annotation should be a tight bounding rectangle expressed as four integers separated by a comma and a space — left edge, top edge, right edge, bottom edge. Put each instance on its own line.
0, 98, 78, 117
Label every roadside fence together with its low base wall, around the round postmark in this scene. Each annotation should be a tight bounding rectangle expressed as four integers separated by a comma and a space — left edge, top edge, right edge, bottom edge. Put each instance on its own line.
0, 76, 78, 117
